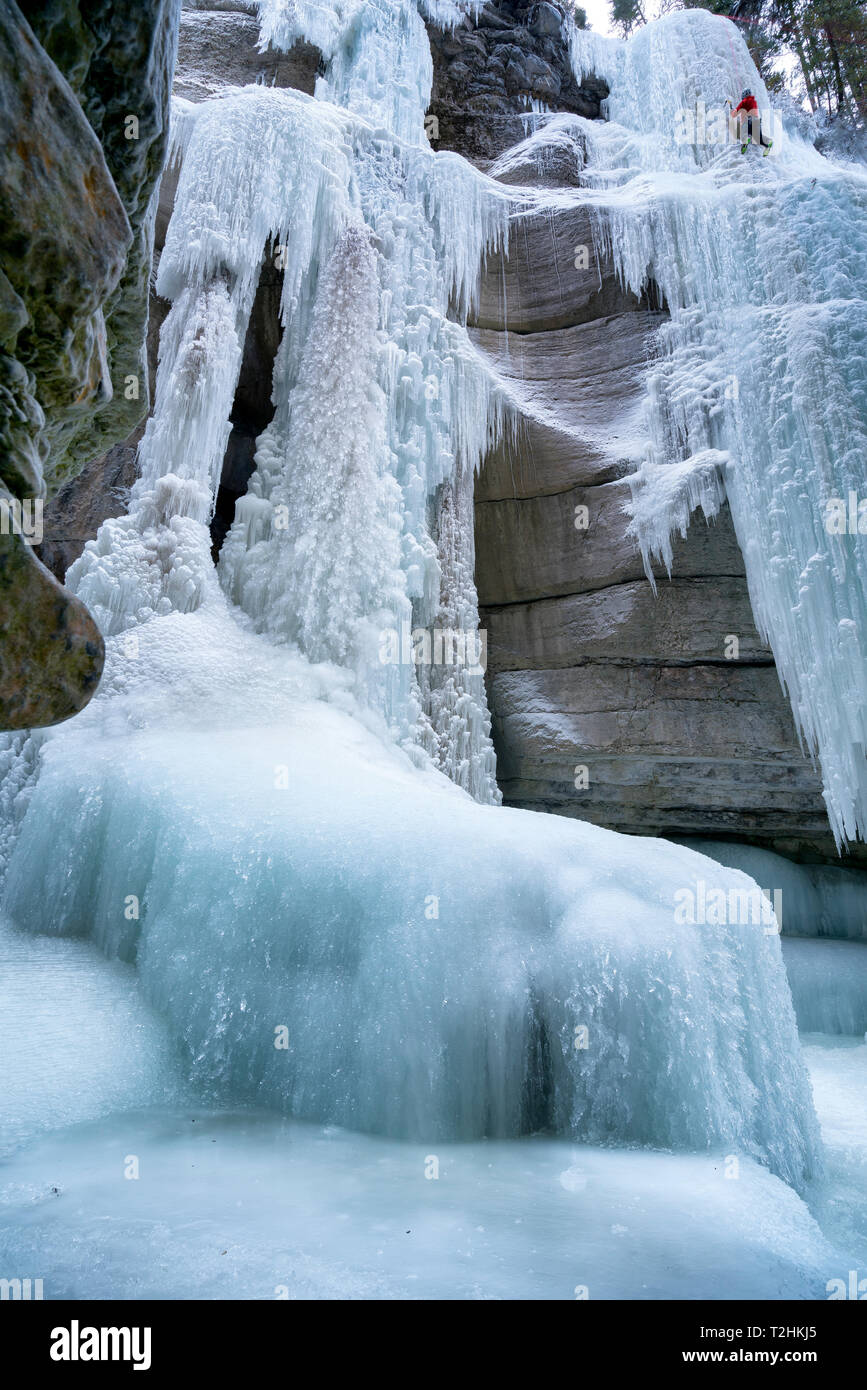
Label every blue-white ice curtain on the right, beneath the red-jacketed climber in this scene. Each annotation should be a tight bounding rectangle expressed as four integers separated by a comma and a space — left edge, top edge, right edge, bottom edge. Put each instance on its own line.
561, 10, 867, 842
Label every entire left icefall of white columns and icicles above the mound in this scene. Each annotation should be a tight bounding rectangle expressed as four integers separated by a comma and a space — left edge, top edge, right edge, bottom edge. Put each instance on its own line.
69, 3, 509, 802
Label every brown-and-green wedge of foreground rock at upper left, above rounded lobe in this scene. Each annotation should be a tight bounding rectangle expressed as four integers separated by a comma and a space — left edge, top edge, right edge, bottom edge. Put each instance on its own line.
0, 0, 132, 496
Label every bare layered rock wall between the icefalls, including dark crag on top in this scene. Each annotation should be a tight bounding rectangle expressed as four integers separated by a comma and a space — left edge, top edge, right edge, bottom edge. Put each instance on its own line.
419, 3, 859, 862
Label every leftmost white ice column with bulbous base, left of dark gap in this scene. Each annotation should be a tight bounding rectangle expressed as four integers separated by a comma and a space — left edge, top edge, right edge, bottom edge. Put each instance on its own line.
67, 89, 349, 635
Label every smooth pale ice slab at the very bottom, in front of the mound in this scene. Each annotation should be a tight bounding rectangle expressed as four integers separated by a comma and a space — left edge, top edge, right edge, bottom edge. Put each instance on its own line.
0, 1095, 867, 1298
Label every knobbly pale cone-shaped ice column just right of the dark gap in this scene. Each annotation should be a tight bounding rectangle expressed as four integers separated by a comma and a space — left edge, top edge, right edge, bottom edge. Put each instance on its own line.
221, 225, 408, 711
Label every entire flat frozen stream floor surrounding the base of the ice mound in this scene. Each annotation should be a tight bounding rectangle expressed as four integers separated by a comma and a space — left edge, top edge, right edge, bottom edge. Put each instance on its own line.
0, 933, 867, 1300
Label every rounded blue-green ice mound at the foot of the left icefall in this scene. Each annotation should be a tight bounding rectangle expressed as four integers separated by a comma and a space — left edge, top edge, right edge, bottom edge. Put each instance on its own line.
6, 600, 817, 1187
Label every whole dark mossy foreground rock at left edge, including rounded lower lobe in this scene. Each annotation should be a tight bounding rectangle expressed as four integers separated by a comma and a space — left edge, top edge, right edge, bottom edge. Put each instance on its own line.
0, 0, 178, 728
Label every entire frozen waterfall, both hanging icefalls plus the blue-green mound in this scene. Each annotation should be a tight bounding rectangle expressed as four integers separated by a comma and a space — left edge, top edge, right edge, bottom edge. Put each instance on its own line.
3, 0, 839, 1188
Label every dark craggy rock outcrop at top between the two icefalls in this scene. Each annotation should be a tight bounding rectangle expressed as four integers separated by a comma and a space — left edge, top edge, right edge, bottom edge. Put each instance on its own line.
429, 0, 609, 165
